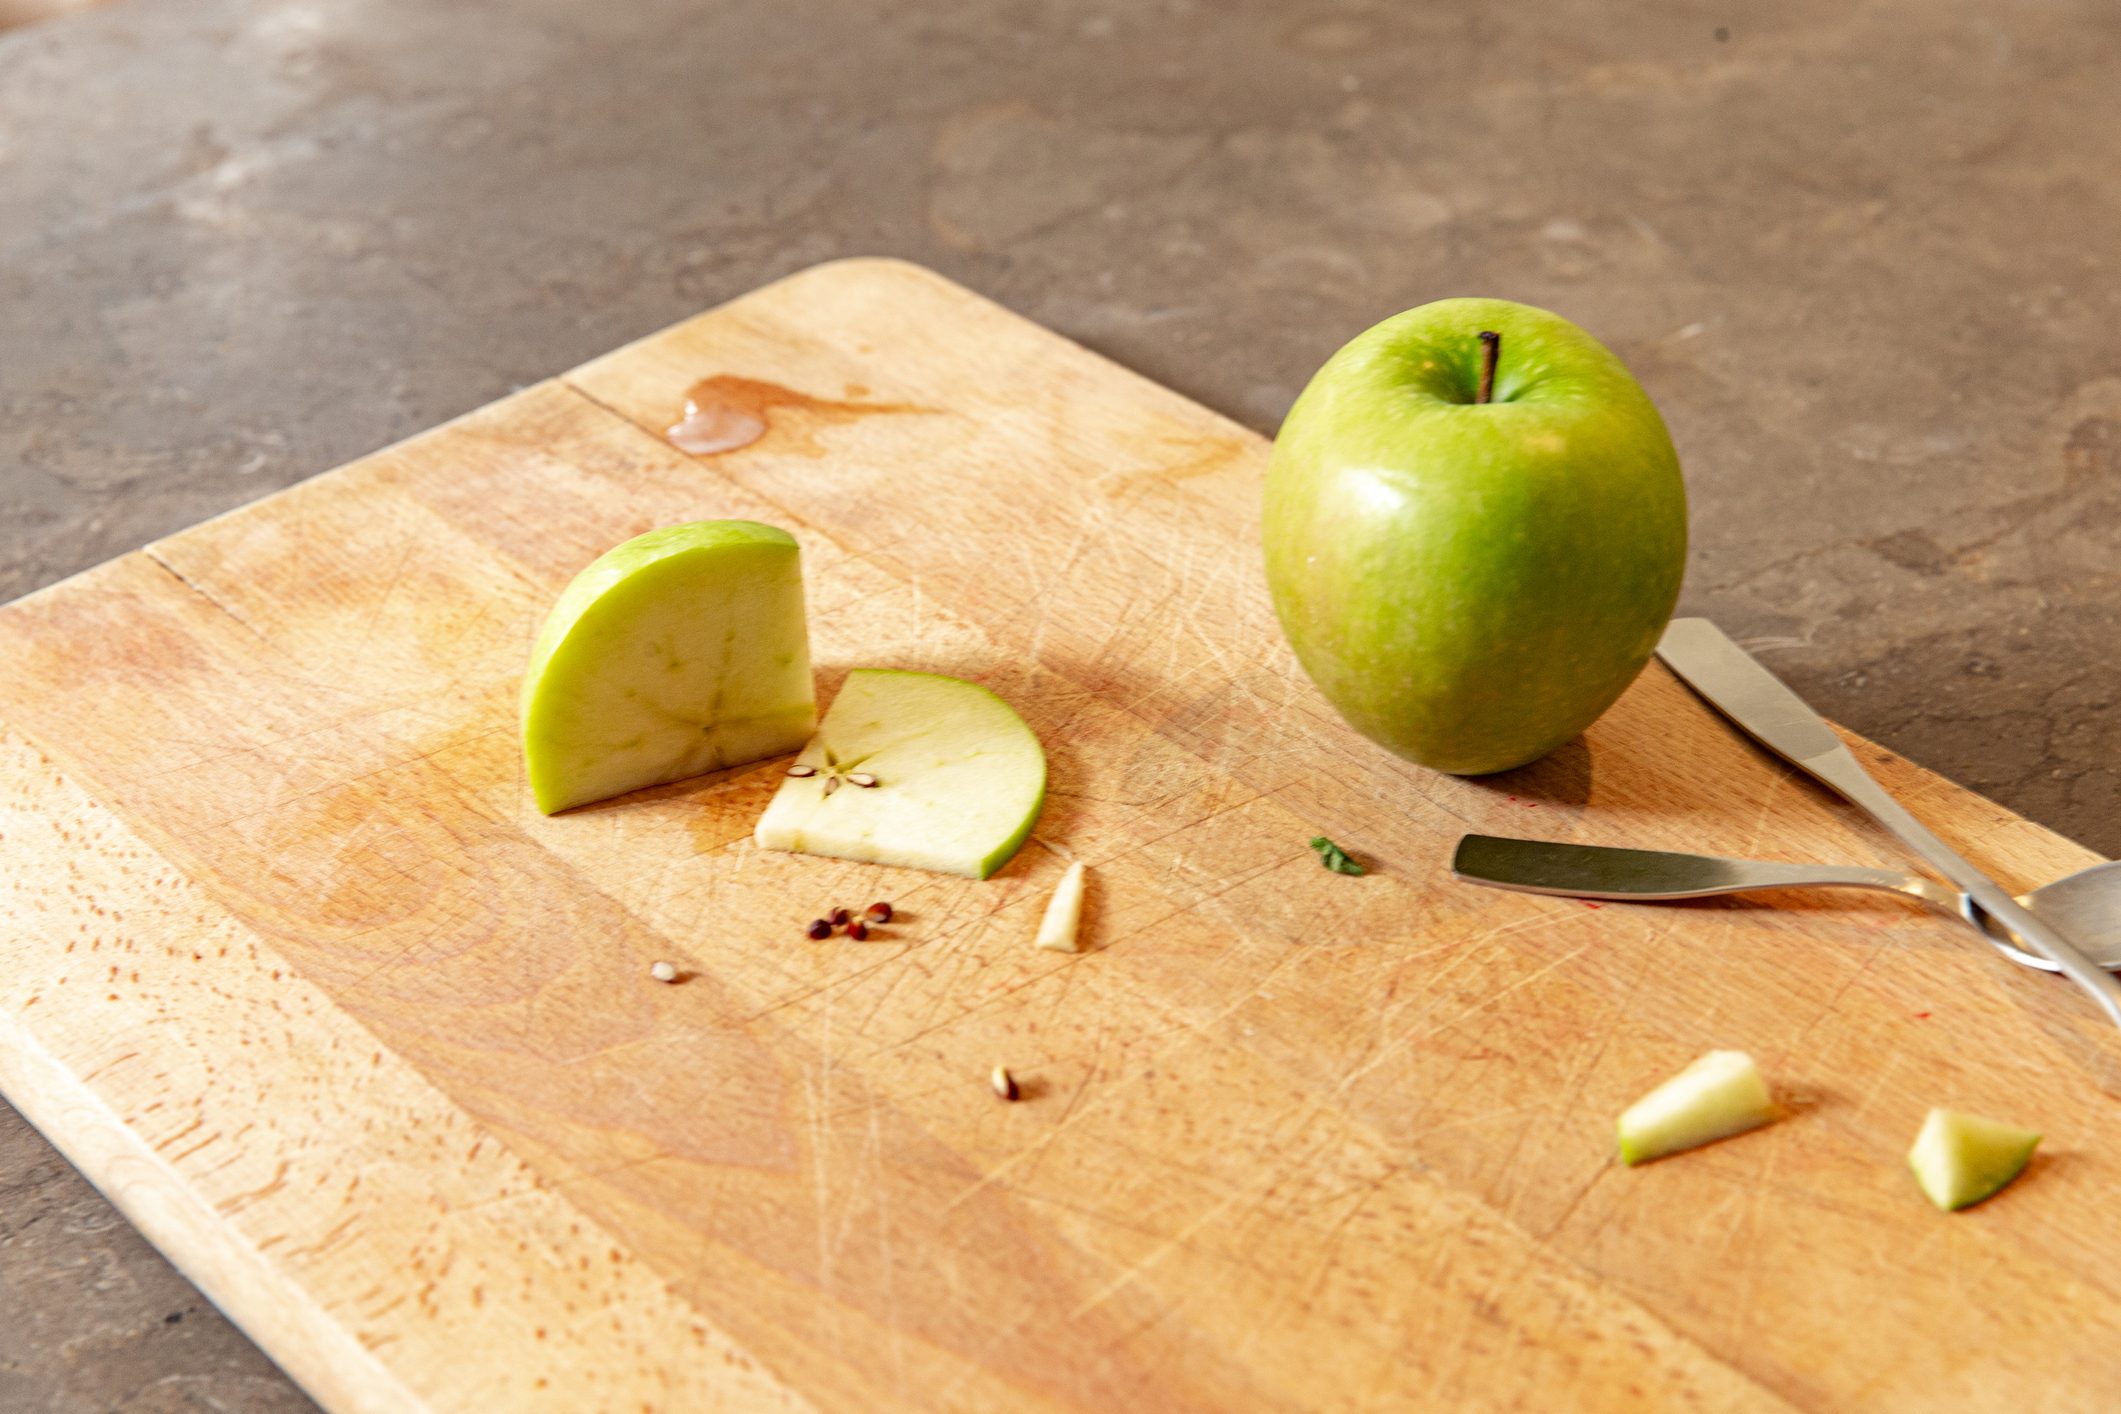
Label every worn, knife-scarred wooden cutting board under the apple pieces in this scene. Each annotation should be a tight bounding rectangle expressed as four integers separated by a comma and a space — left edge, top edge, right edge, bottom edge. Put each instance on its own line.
0, 261, 2121, 1412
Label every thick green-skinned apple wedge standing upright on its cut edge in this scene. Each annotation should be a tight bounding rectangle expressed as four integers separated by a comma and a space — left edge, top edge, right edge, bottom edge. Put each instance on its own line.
522, 519, 817, 814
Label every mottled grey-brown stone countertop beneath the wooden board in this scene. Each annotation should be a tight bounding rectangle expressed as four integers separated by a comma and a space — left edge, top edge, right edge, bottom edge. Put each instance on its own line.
0, 0, 2121, 1414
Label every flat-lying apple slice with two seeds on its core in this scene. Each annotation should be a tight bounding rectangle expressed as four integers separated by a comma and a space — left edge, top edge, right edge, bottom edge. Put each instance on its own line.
755, 668, 1046, 880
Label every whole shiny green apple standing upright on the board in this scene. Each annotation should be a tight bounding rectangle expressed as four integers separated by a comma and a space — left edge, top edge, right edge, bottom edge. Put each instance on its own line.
1262, 299, 1686, 776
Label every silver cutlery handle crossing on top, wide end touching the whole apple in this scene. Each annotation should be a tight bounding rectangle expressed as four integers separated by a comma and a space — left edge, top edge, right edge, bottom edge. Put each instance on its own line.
1657, 619, 2121, 1026
